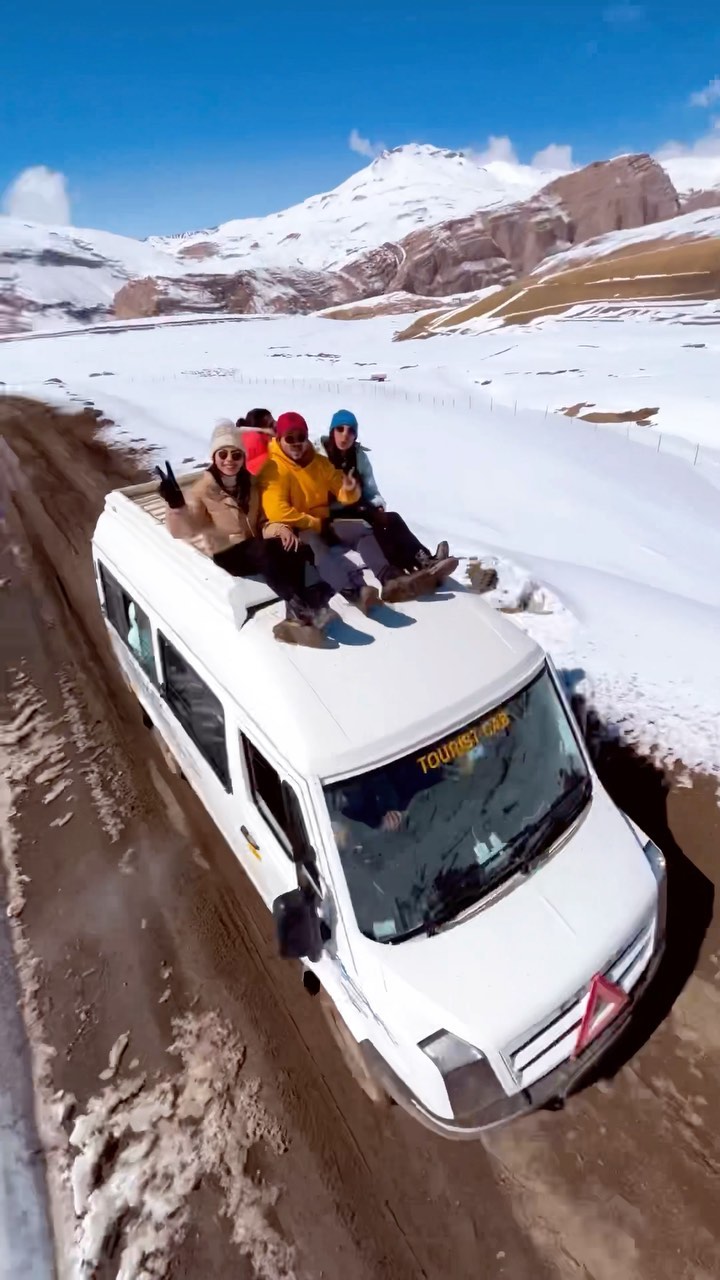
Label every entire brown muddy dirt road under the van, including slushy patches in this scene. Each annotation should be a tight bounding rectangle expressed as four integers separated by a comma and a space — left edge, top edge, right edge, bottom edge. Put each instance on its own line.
0, 397, 720, 1280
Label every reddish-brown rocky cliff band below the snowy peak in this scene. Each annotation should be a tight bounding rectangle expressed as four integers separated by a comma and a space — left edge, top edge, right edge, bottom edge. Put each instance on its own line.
115, 155, 680, 319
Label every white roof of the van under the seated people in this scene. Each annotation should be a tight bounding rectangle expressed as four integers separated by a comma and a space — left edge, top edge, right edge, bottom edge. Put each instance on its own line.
94, 477, 544, 780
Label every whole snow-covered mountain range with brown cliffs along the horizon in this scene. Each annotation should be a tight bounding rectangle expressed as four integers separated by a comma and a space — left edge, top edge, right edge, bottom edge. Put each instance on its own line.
0, 145, 720, 333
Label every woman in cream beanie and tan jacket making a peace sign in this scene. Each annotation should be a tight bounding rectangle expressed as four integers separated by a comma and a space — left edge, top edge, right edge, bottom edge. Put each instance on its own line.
156, 421, 334, 646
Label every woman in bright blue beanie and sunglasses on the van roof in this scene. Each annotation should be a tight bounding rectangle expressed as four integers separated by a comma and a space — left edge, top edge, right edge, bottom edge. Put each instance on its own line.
322, 408, 457, 585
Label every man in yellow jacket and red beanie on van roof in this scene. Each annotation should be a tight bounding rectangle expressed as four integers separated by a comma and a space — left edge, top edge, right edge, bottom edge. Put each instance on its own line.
260, 413, 433, 613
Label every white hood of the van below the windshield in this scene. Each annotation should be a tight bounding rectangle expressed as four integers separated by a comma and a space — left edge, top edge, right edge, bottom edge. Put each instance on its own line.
368, 781, 657, 1050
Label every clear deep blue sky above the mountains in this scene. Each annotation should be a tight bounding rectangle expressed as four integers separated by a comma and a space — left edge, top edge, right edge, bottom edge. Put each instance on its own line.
0, 0, 720, 236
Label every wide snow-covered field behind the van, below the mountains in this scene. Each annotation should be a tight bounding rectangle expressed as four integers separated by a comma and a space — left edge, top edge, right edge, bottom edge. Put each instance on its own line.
0, 317, 720, 776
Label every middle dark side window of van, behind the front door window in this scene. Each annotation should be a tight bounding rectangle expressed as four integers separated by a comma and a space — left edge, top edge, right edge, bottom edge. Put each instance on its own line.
158, 631, 232, 791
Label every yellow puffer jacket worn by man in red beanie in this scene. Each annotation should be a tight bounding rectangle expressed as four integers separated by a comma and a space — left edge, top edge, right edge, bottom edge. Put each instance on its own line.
259, 440, 357, 532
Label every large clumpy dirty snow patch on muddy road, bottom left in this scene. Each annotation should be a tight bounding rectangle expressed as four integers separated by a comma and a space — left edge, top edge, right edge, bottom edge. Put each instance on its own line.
70, 1012, 295, 1280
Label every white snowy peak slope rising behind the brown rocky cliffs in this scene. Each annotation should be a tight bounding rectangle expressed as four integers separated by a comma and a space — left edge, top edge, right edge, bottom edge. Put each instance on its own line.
152, 143, 560, 271
